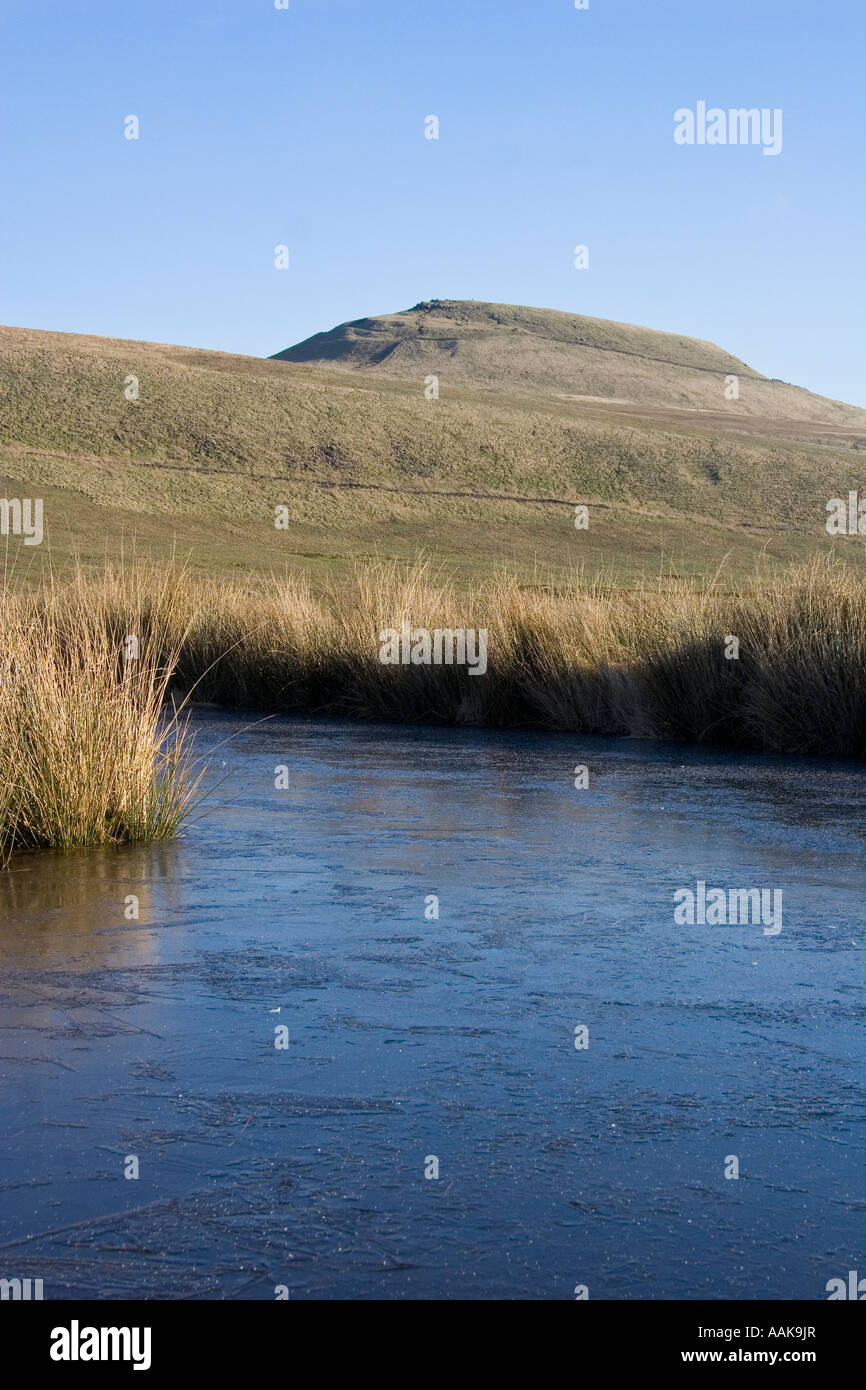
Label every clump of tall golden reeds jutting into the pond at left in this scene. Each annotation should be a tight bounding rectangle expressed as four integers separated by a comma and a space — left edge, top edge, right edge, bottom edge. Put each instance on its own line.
0, 574, 199, 853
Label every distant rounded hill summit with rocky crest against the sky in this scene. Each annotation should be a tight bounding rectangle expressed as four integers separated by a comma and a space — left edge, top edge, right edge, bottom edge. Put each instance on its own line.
274, 299, 866, 428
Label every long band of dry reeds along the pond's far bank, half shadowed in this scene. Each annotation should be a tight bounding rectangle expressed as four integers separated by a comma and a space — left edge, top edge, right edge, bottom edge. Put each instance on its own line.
37, 559, 866, 758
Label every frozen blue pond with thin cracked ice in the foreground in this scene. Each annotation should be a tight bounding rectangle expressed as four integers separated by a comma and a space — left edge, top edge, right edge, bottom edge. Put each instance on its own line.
0, 712, 866, 1300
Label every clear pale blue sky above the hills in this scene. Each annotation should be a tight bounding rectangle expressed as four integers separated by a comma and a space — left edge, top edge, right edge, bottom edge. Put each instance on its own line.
0, 0, 866, 406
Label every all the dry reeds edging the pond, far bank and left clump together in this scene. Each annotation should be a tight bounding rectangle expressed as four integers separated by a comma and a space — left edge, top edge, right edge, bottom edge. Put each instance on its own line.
0, 560, 866, 847
